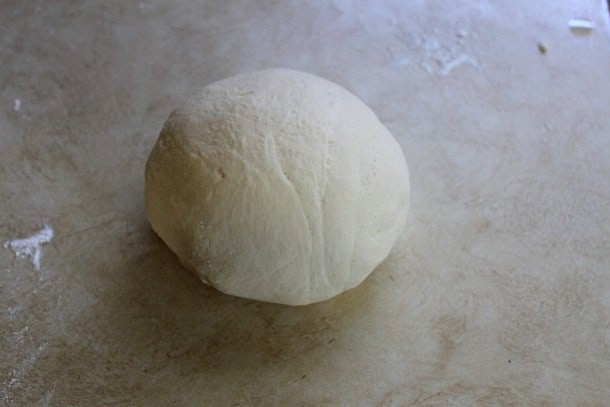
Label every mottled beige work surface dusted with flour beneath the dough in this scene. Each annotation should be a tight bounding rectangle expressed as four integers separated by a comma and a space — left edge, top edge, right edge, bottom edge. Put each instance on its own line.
0, 0, 610, 407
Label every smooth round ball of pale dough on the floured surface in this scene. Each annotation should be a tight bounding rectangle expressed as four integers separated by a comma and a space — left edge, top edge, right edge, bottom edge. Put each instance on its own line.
146, 69, 409, 305
